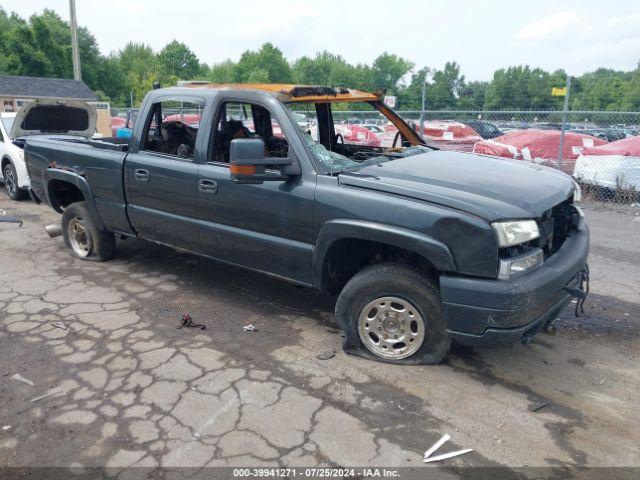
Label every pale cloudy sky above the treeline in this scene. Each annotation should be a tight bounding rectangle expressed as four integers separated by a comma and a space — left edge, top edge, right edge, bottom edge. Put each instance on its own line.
1, 0, 640, 80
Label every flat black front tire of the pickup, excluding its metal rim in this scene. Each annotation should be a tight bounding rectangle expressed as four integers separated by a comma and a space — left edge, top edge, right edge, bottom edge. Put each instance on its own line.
336, 263, 451, 365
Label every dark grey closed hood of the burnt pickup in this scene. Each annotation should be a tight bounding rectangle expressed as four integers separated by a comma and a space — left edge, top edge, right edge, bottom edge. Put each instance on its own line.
339, 150, 574, 222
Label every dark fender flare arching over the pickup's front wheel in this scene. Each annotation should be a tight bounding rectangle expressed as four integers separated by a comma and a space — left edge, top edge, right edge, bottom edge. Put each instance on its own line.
311, 220, 456, 288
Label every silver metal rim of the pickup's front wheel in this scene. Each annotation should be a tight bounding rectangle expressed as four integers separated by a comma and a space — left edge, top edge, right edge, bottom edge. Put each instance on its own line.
358, 297, 425, 360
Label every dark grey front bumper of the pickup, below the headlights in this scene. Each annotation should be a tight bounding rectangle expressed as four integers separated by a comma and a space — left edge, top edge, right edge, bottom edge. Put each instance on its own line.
440, 222, 589, 345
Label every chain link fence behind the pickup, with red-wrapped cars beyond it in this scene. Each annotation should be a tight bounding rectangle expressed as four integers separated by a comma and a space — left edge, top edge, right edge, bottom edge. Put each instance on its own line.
111, 109, 640, 203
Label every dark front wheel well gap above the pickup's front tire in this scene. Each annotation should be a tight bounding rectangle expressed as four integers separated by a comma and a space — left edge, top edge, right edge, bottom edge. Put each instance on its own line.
322, 238, 438, 294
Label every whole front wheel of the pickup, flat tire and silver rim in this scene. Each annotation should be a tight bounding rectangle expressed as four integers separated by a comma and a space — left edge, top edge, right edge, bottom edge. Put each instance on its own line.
336, 263, 451, 364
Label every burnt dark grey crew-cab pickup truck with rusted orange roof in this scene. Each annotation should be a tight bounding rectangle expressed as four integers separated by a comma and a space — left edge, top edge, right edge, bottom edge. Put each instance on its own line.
22, 84, 589, 363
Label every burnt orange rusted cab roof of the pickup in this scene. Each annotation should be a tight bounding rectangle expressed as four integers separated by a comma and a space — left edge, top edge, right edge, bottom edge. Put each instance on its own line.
181, 82, 381, 103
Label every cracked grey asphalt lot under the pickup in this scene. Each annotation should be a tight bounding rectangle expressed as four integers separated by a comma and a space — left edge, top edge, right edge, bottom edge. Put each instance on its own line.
0, 196, 640, 477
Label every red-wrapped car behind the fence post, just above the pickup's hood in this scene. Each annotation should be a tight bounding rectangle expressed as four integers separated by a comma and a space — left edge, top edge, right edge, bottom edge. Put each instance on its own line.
473, 128, 607, 175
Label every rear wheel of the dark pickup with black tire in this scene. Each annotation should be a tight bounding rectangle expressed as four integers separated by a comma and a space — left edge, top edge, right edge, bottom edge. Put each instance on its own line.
62, 202, 116, 262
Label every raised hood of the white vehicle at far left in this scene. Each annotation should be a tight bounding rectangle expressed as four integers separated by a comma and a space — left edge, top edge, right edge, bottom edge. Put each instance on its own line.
10, 100, 98, 138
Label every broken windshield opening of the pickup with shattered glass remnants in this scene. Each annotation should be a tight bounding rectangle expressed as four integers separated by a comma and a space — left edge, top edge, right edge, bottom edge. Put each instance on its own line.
287, 102, 431, 174
